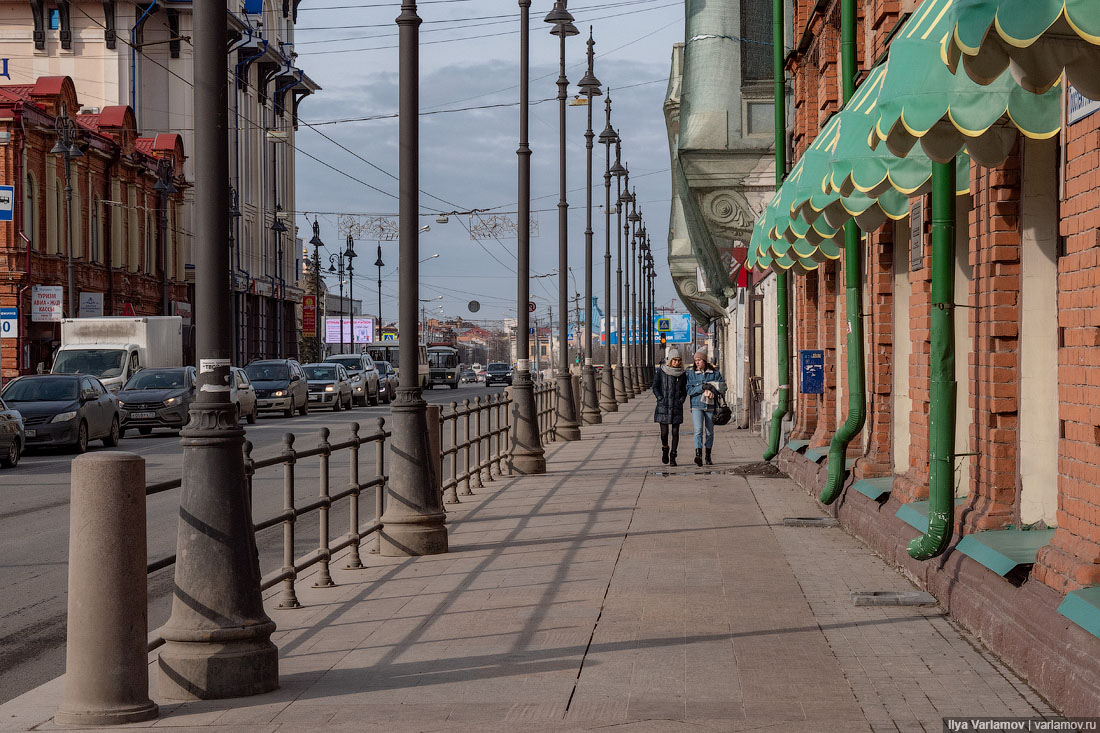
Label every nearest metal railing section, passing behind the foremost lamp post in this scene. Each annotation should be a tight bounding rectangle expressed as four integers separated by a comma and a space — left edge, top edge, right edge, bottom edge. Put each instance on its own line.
145, 417, 392, 650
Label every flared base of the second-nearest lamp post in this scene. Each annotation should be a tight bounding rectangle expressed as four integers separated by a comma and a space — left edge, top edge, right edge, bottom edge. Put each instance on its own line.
380, 387, 448, 557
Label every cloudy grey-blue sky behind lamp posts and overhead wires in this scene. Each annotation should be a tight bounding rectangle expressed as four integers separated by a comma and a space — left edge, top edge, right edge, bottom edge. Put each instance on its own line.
295, 0, 684, 322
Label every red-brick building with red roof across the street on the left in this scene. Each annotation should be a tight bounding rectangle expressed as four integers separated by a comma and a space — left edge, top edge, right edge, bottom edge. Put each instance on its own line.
0, 76, 191, 380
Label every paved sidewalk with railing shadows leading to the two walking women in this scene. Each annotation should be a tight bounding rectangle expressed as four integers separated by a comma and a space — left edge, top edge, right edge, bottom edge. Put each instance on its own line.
0, 397, 1053, 733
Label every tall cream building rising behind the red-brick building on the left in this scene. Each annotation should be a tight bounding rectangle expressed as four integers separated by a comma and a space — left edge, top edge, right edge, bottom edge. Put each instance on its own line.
0, 0, 319, 363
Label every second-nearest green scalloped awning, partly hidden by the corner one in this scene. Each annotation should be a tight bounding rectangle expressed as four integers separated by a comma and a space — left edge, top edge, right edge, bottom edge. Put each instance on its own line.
871, 0, 1062, 166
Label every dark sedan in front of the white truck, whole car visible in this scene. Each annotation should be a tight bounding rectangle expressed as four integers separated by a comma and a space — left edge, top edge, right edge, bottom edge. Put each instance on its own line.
0, 374, 121, 453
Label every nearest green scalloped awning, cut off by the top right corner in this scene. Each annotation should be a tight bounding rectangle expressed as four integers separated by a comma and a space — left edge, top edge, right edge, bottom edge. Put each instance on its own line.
944, 0, 1100, 99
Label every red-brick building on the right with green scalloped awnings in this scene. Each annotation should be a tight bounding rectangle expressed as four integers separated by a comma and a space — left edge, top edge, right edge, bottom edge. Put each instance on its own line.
670, 0, 1100, 715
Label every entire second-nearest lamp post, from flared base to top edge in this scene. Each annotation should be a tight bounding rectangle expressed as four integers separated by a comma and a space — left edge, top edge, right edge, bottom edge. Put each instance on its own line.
380, 0, 448, 557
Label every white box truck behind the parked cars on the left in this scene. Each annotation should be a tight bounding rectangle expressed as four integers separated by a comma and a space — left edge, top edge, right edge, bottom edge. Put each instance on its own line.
50, 316, 184, 392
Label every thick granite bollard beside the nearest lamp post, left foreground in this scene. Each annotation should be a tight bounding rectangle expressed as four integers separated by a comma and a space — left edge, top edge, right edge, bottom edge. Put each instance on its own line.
54, 451, 157, 725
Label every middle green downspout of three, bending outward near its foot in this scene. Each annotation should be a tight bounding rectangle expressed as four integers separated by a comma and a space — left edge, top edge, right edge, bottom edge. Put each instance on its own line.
817, 0, 867, 504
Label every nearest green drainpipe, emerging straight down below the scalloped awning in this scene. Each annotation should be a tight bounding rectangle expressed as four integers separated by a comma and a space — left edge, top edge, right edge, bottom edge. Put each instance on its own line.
908, 161, 956, 560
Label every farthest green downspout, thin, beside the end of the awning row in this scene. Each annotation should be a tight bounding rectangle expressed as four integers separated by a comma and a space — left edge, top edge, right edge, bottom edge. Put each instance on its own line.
763, 0, 791, 461
